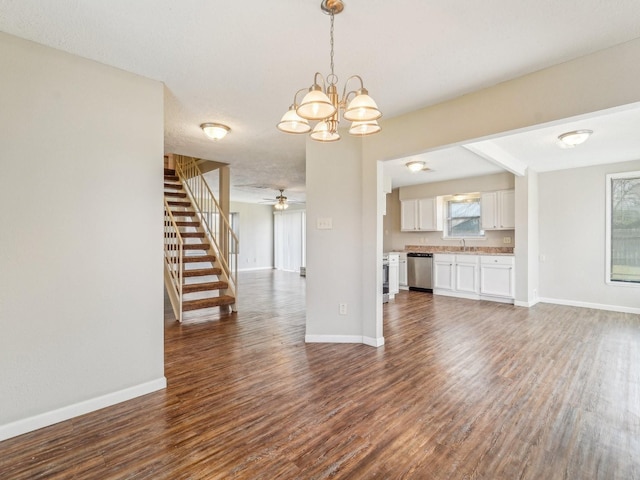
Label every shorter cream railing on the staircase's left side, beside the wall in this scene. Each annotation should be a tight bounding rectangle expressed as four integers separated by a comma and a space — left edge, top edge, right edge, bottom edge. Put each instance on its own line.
164, 199, 184, 322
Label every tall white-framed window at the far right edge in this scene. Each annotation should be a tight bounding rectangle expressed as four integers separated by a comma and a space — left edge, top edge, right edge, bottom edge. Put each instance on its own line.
606, 172, 640, 285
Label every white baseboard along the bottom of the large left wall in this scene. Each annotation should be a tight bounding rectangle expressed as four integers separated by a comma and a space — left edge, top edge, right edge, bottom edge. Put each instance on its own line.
0, 377, 167, 441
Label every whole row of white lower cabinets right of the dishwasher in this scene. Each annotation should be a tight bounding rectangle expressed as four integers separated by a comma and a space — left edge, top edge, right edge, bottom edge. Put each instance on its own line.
433, 254, 515, 303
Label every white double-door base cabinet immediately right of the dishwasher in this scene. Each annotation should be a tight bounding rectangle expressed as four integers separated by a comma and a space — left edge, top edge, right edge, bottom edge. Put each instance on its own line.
433, 254, 480, 298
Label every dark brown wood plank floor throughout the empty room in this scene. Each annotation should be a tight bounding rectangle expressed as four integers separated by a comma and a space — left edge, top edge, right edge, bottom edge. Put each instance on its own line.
0, 271, 640, 480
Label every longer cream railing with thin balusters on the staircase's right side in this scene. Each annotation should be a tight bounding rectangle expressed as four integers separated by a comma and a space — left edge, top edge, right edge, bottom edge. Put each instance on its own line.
175, 155, 239, 298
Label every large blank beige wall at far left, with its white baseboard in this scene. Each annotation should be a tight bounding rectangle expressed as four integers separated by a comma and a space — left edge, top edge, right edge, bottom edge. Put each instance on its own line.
0, 33, 166, 440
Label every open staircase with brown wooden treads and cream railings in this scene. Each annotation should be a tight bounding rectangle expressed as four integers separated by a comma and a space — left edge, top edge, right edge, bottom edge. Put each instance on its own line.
164, 164, 237, 321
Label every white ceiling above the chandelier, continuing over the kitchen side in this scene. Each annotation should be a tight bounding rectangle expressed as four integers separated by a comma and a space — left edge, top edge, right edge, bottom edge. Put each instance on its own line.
0, 0, 640, 201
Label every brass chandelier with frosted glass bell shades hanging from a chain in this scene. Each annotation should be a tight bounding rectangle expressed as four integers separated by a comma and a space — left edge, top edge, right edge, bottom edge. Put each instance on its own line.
278, 0, 382, 142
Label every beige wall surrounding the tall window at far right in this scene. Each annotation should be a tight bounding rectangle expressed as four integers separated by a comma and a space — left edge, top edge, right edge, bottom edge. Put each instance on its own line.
539, 160, 640, 313
